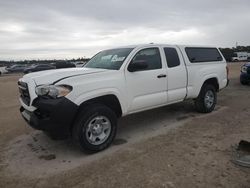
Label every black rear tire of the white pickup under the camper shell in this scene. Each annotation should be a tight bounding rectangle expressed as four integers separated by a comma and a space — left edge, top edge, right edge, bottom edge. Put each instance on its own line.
195, 84, 217, 113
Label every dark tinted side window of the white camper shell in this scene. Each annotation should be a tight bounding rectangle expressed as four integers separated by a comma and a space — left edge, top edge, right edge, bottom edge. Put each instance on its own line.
185, 47, 223, 63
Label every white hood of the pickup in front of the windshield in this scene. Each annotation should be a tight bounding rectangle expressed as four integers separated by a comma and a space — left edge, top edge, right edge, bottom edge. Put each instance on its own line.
23, 68, 107, 85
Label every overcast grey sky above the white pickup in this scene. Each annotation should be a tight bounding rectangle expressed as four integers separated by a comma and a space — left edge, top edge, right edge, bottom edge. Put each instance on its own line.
0, 0, 250, 60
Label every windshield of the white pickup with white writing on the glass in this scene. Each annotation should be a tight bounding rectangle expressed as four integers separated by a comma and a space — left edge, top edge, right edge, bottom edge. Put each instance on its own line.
84, 48, 133, 70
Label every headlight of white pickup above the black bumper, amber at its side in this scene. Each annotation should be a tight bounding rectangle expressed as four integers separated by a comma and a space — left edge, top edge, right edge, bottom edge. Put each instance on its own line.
36, 85, 72, 98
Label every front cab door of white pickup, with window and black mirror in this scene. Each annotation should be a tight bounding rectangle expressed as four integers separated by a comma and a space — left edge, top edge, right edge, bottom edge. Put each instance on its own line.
125, 47, 167, 113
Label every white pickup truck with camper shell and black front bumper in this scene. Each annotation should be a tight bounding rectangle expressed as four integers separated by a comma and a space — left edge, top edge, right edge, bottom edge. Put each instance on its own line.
18, 44, 228, 152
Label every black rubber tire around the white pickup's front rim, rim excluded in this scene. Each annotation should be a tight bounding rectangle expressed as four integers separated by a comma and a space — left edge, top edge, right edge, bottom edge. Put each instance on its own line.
72, 104, 117, 153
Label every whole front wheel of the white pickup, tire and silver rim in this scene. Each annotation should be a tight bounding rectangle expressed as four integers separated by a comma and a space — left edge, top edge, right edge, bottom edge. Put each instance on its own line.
72, 104, 117, 152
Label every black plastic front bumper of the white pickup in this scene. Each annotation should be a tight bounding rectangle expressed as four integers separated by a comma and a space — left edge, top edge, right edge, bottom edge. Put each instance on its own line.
20, 97, 78, 135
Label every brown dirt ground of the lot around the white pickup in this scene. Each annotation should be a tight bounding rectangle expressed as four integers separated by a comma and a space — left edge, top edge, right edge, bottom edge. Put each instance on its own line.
0, 63, 250, 188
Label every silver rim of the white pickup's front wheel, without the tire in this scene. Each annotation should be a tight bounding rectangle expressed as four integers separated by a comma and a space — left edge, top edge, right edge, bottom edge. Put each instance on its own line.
86, 116, 111, 145
